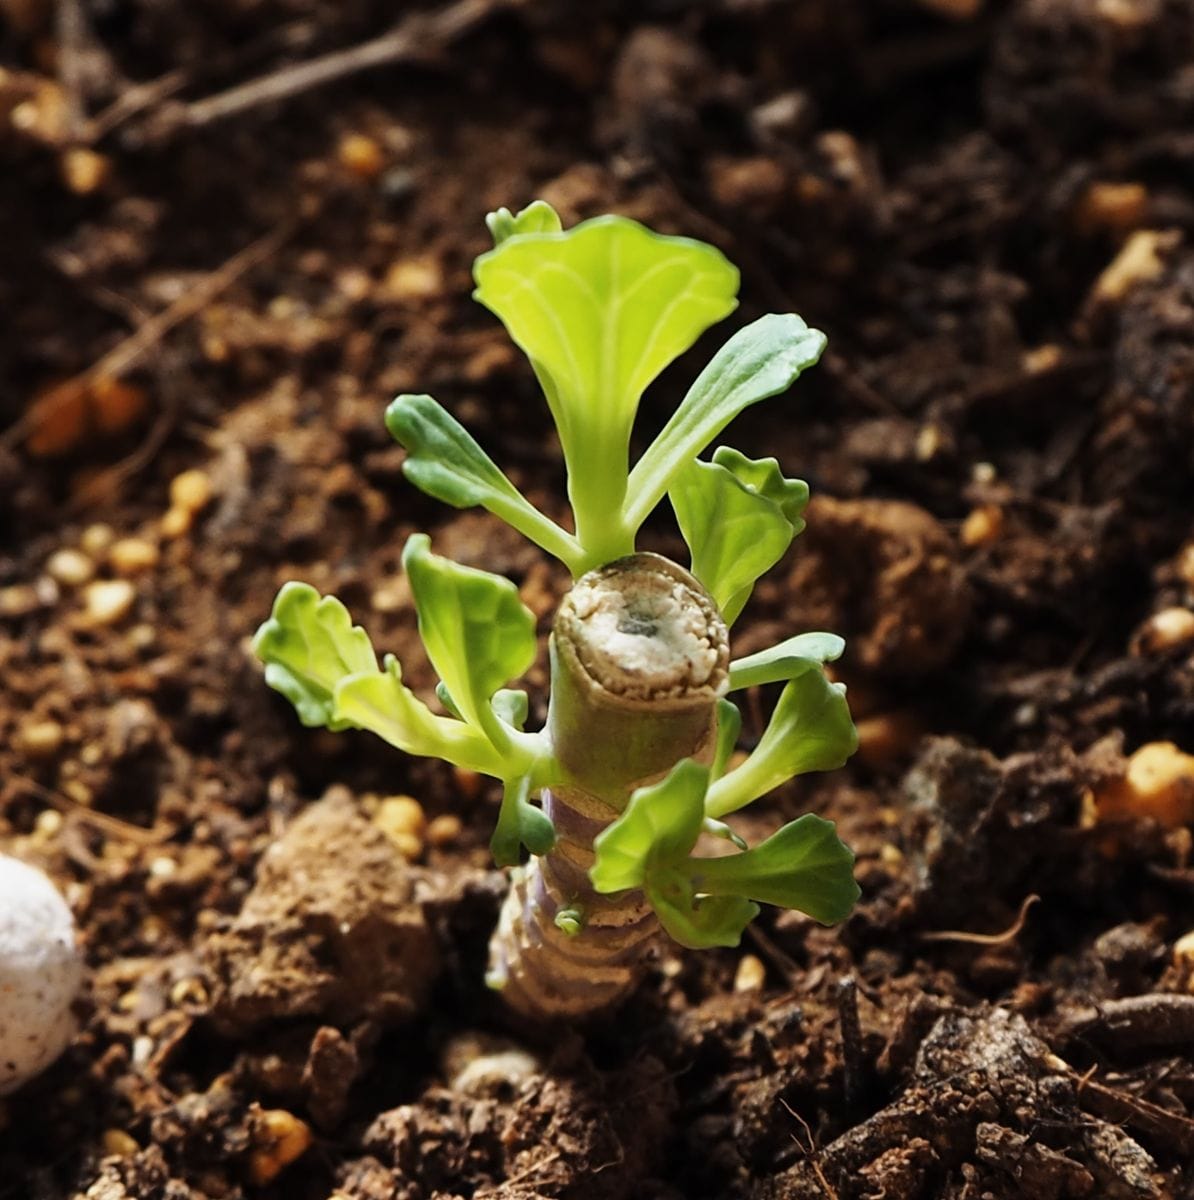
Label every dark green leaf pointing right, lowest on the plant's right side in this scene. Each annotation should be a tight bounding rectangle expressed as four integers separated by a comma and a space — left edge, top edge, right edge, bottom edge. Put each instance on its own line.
691, 812, 859, 925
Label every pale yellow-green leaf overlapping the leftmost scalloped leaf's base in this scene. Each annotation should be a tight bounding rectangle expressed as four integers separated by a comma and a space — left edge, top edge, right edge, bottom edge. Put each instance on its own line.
334, 655, 511, 779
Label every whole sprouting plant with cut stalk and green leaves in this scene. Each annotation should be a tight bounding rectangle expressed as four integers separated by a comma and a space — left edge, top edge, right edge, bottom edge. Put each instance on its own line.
254, 202, 858, 1019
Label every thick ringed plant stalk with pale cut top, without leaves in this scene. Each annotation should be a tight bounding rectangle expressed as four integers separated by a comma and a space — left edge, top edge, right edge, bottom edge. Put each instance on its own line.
488, 554, 730, 1020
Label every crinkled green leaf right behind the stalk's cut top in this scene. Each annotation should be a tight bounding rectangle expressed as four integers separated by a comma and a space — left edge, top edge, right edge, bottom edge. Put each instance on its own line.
668, 448, 809, 625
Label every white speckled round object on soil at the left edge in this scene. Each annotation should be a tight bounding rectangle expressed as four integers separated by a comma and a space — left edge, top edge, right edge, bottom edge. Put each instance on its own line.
0, 854, 83, 1096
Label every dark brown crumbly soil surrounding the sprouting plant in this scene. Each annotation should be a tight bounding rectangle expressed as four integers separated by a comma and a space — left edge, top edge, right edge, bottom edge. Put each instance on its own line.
0, 0, 1194, 1200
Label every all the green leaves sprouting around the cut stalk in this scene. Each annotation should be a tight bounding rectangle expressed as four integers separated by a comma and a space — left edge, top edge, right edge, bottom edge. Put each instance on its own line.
253, 202, 857, 946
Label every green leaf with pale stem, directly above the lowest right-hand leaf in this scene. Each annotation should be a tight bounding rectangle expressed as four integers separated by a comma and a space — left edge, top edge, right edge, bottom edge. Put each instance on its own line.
704, 670, 858, 817
